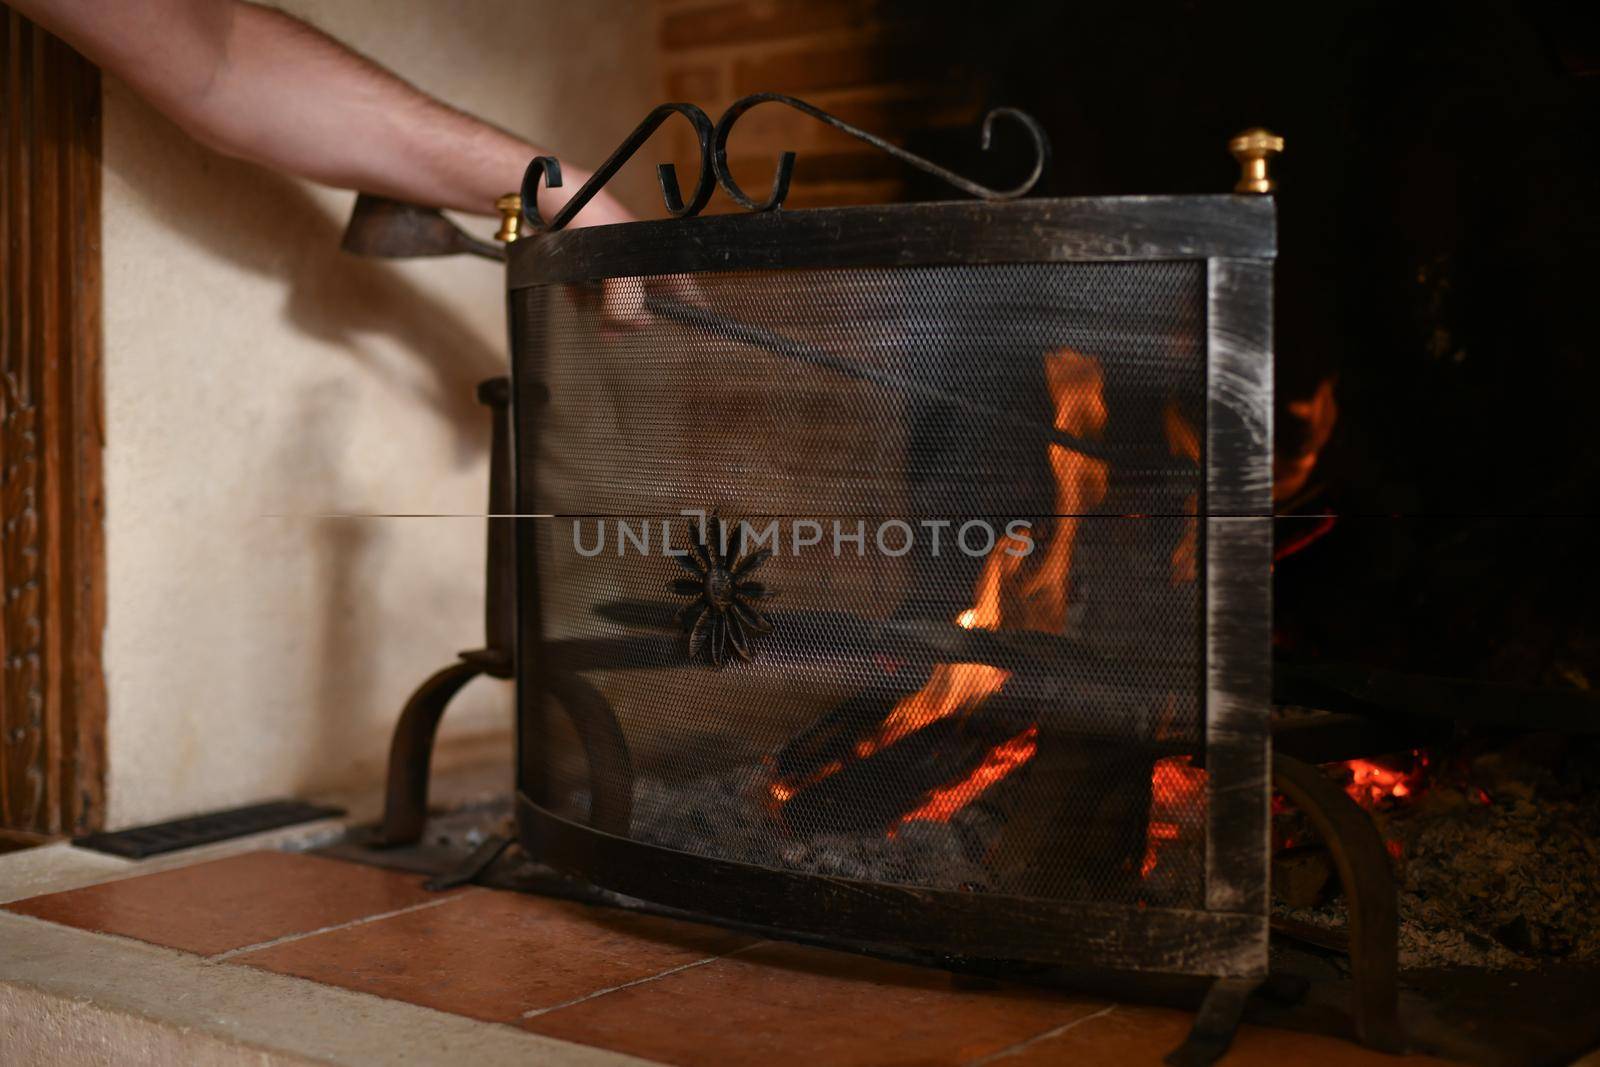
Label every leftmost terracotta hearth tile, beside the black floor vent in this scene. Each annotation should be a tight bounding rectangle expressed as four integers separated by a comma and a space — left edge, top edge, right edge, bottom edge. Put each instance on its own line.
5, 853, 440, 955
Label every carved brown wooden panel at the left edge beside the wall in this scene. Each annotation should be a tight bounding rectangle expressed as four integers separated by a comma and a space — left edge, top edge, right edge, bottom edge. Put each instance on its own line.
0, 6, 106, 833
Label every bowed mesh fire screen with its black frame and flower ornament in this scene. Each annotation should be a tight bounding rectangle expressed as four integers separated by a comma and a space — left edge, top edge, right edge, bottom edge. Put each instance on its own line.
509, 197, 1274, 974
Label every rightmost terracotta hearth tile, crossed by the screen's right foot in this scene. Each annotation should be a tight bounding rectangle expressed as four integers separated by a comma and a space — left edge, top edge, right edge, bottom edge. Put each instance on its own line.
995, 1005, 1448, 1067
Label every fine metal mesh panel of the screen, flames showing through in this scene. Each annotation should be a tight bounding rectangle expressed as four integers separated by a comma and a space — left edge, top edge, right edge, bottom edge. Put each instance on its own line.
514, 262, 1205, 907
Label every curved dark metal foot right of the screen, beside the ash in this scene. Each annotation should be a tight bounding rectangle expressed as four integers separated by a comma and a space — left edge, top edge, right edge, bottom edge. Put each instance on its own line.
1272, 752, 1405, 1053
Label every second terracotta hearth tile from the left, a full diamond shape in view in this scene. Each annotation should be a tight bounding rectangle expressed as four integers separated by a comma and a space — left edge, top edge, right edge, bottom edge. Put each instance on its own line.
232, 889, 750, 1022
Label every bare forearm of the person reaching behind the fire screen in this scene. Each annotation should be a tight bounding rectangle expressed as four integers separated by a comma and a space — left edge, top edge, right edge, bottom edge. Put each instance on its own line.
16, 0, 627, 222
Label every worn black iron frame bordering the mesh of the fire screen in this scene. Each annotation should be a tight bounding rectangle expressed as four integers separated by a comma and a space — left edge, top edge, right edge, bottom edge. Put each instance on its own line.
507, 197, 1275, 977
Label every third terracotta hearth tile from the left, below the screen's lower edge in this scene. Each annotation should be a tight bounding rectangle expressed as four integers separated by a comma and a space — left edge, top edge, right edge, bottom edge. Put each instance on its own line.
523, 944, 1114, 1067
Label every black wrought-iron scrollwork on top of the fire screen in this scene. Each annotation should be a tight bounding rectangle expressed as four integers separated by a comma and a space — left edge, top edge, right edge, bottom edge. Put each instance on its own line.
522, 93, 1050, 232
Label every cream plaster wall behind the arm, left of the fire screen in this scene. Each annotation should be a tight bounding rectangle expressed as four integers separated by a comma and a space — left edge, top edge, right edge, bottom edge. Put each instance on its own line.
104, 0, 658, 827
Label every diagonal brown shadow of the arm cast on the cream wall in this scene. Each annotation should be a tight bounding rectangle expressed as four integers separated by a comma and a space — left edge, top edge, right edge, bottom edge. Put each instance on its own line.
104, 90, 506, 464
